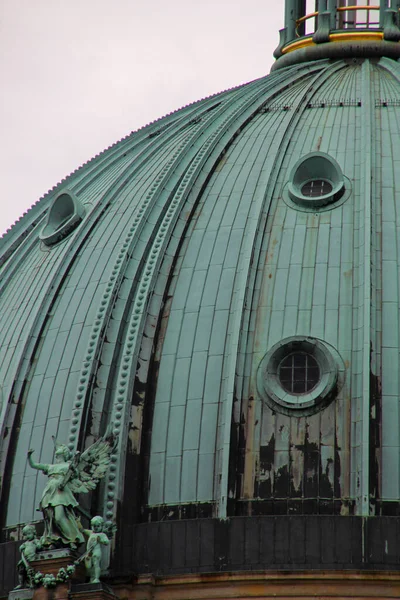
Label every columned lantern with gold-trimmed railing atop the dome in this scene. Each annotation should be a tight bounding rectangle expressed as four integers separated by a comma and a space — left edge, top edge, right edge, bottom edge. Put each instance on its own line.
274, 0, 400, 66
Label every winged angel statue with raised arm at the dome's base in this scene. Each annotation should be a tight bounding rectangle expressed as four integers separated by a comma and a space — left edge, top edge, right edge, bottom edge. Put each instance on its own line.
28, 434, 115, 549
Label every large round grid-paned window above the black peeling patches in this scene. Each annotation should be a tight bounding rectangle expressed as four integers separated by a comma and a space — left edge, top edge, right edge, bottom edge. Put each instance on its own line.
257, 336, 344, 416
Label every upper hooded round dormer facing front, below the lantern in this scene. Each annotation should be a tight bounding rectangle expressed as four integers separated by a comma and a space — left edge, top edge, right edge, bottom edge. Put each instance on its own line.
284, 152, 350, 210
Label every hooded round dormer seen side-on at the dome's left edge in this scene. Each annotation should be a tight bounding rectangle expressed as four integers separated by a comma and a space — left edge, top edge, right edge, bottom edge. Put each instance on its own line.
39, 190, 85, 246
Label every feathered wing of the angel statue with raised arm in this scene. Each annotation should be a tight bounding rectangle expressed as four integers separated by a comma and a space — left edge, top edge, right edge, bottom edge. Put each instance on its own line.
68, 433, 116, 494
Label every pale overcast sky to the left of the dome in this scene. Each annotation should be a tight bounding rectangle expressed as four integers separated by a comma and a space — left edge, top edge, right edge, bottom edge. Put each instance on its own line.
0, 0, 284, 234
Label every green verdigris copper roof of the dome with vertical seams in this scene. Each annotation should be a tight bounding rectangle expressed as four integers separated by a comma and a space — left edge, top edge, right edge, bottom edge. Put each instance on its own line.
0, 58, 400, 526
